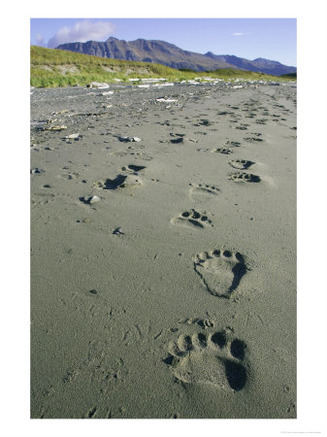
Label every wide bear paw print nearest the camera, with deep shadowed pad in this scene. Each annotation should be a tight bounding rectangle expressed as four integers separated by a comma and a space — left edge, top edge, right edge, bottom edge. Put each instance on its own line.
164, 330, 247, 391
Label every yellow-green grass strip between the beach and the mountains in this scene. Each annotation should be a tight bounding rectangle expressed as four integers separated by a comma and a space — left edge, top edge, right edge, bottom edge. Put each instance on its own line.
30, 46, 294, 87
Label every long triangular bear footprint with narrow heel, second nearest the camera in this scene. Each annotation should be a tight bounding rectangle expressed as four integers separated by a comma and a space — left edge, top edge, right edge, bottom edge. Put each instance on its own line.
193, 249, 248, 298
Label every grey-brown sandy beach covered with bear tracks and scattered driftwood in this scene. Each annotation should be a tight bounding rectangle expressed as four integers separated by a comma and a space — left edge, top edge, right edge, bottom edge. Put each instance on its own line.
30, 82, 297, 419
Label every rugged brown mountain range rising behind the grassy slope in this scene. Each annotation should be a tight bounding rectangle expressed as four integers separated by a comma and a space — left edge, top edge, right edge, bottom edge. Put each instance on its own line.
57, 37, 296, 76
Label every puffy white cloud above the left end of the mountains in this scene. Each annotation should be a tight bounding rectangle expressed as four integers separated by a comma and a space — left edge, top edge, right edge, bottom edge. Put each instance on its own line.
48, 20, 114, 48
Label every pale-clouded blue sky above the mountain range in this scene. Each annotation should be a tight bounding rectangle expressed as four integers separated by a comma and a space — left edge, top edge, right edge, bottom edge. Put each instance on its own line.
30, 18, 297, 66
